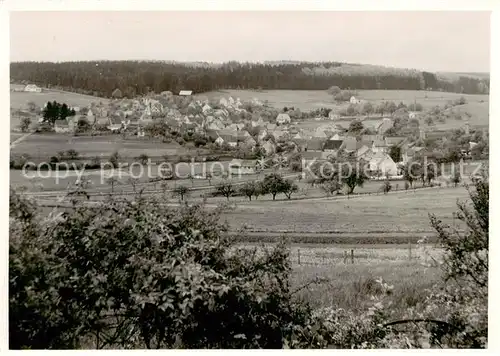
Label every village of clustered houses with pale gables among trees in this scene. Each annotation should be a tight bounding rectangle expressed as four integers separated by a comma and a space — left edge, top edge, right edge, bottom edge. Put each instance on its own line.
13, 85, 476, 184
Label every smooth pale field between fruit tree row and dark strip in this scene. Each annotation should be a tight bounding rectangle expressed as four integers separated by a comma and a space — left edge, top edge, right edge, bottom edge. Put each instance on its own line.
224, 187, 468, 238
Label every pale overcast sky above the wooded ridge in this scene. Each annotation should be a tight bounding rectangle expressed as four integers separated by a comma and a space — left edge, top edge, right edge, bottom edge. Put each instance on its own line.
10, 12, 490, 72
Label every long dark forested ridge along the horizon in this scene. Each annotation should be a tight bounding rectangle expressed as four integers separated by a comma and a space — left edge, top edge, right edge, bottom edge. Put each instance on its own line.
10, 61, 489, 97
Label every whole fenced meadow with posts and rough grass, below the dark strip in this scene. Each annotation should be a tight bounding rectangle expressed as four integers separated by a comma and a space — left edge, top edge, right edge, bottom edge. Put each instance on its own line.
240, 244, 442, 312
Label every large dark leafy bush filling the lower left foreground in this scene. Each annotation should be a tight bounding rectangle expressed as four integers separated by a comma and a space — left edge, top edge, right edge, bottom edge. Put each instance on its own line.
9, 194, 308, 349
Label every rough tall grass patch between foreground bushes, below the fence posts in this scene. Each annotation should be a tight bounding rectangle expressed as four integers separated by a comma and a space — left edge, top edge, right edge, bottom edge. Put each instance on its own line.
292, 260, 441, 317
